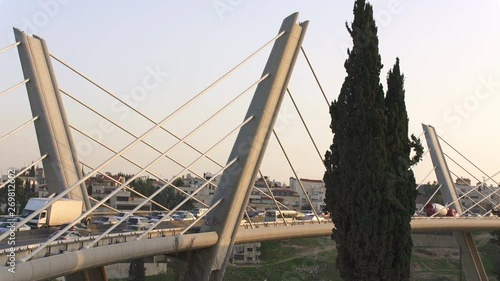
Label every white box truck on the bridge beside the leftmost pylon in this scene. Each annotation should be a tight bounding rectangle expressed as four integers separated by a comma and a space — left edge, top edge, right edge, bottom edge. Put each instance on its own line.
21, 198, 83, 228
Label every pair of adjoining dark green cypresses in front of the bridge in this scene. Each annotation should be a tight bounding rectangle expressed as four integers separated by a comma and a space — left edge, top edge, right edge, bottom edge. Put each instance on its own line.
324, 0, 423, 281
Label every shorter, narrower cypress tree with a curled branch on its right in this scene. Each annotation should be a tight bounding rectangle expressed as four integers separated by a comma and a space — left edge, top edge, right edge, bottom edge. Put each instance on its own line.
385, 58, 423, 280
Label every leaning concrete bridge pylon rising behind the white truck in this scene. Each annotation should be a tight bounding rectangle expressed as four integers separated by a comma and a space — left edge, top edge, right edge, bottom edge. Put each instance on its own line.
14, 29, 90, 209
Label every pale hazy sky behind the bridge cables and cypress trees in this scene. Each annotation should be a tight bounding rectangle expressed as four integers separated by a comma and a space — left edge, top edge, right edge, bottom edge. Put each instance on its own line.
0, 0, 500, 186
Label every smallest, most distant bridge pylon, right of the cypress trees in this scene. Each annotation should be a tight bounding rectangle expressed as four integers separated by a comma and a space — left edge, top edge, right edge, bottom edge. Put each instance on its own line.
422, 124, 488, 281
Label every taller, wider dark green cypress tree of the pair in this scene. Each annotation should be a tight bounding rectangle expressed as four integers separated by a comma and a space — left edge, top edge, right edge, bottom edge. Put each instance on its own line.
324, 0, 397, 281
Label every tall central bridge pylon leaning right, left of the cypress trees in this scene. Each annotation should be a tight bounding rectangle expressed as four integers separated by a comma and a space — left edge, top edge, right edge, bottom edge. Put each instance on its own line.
185, 13, 308, 281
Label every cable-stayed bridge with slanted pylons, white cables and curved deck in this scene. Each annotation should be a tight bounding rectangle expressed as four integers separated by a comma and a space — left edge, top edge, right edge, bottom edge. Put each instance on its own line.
0, 14, 500, 280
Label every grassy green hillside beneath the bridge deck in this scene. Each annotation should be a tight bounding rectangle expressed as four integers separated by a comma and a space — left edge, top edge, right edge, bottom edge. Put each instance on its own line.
111, 233, 500, 281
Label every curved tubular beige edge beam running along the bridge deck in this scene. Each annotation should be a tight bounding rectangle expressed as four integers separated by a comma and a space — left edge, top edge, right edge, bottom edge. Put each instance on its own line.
0, 217, 500, 281
